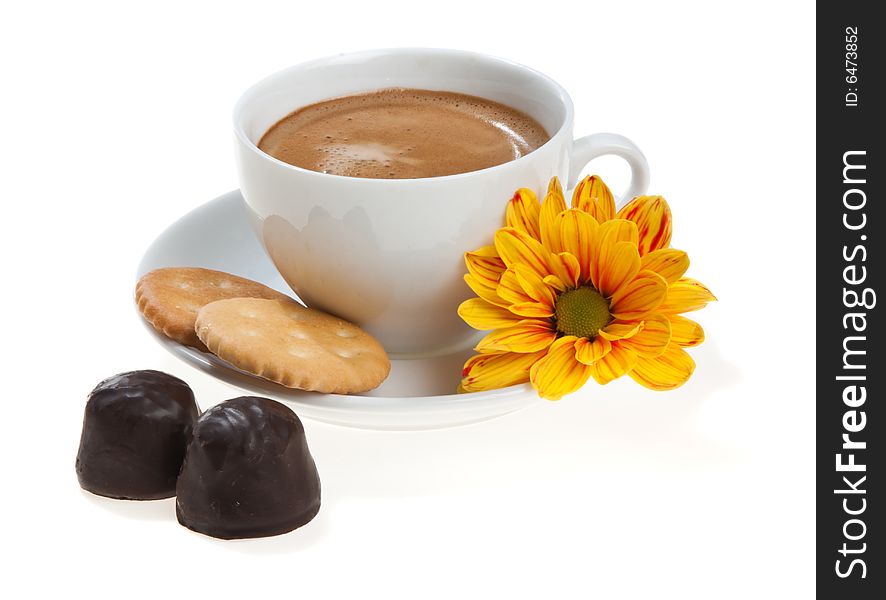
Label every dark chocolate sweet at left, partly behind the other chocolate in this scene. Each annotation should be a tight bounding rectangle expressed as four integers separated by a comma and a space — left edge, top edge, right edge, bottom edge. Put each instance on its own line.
75, 371, 200, 500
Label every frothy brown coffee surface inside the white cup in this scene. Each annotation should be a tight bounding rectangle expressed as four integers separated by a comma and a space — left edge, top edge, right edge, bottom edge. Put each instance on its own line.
258, 88, 549, 179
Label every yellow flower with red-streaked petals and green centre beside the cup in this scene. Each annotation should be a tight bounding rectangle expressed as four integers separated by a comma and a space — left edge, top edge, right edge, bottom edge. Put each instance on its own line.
458, 176, 716, 400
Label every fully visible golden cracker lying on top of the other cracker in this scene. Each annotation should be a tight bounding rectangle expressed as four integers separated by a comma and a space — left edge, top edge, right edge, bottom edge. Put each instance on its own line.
196, 298, 391, 394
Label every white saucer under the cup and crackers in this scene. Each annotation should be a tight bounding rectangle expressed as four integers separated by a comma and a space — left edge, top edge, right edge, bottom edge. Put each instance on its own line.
138, 191, 538, 430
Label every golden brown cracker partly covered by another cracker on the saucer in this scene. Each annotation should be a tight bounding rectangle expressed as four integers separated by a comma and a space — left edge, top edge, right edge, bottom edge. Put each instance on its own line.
135, 267, 289, 351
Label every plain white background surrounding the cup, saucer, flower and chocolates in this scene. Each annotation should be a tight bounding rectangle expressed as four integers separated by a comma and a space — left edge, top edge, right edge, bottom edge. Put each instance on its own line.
0, 0, 815, 598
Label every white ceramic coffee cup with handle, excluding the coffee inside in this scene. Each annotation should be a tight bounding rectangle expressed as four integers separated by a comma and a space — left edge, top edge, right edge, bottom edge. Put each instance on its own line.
234, 48, 649, 357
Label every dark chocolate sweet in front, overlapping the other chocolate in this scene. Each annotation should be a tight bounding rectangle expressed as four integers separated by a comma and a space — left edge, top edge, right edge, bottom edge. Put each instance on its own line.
175, 396, 320, 539
